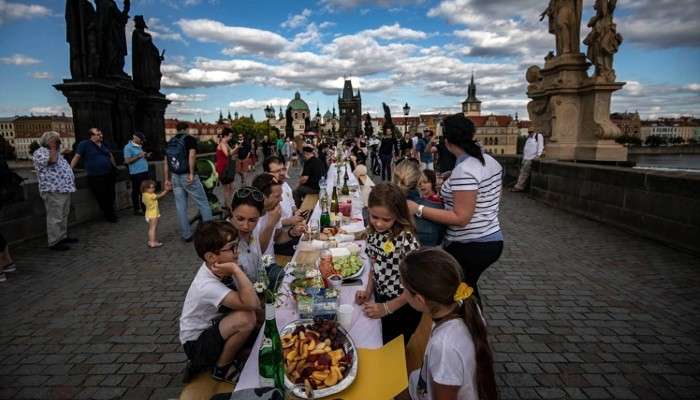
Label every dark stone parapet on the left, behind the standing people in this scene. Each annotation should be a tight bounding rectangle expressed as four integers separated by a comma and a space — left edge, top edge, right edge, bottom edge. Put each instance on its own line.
0, 153, 214, 243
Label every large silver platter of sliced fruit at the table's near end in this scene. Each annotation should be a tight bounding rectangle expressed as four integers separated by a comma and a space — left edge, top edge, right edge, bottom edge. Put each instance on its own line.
280, 319, 357, 399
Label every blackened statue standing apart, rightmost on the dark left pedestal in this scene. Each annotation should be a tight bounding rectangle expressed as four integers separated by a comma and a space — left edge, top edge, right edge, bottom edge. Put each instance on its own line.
131, 15, 165, 93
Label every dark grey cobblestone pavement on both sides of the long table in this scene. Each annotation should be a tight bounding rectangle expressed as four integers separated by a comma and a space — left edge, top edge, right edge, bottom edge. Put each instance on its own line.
0, 165, 700, 399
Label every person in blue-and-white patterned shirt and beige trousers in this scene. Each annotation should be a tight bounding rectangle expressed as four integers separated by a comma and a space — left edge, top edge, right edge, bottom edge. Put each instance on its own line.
32, 131, 78, 251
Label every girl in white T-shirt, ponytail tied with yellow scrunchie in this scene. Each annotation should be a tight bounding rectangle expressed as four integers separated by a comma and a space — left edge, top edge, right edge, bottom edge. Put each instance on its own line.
399, 247, 498, 400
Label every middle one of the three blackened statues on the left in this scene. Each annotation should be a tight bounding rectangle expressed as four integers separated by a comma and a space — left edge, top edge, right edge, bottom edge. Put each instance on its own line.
95, 0, 131, 78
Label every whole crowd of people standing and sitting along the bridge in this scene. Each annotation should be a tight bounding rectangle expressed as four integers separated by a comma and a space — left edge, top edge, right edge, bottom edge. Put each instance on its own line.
0, 110, 542, 399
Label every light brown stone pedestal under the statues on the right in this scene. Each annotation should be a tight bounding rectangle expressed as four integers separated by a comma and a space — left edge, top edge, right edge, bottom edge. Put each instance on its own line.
528, 54, 627, 161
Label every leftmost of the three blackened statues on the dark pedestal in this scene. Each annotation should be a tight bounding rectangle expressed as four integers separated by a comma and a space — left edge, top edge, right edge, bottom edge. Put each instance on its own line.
65, 0, 100, 80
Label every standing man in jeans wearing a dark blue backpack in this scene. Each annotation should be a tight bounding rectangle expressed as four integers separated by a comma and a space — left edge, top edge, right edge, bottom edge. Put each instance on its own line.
163, 122, 212, 242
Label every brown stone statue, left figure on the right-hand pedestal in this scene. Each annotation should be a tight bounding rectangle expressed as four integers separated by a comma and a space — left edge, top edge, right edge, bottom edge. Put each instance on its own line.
540, 0, 583, 56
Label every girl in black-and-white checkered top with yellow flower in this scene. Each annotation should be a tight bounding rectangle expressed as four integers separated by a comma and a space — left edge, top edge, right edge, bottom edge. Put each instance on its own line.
355, 183, 421, 343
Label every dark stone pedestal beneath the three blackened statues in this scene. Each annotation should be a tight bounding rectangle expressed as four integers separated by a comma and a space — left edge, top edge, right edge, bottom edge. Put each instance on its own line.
54, 79, 170, 162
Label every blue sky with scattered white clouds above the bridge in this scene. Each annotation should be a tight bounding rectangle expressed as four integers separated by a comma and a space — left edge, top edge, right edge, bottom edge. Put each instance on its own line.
0, 0, 700, 120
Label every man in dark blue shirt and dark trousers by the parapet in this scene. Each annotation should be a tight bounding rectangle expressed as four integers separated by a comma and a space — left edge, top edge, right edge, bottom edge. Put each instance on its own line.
70, 128, 117, 223
